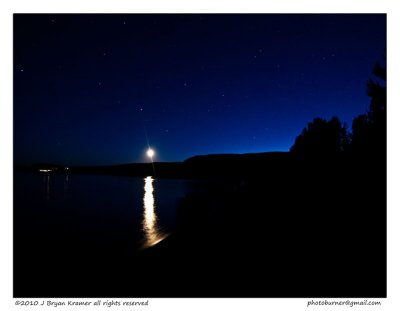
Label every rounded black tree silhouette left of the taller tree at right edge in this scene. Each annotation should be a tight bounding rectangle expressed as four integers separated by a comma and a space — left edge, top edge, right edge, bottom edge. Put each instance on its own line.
290, 117, 348, 157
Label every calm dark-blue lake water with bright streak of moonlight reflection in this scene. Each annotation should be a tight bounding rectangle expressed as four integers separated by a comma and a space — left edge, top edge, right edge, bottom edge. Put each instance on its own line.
14, 173, 192, 249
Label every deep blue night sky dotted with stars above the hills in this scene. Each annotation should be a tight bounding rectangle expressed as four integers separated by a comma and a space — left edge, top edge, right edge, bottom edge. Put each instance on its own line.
13, 14, 386, 165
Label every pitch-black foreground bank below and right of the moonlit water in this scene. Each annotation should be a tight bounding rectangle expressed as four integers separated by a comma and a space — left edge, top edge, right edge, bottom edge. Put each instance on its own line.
14, 155, 386, 297
